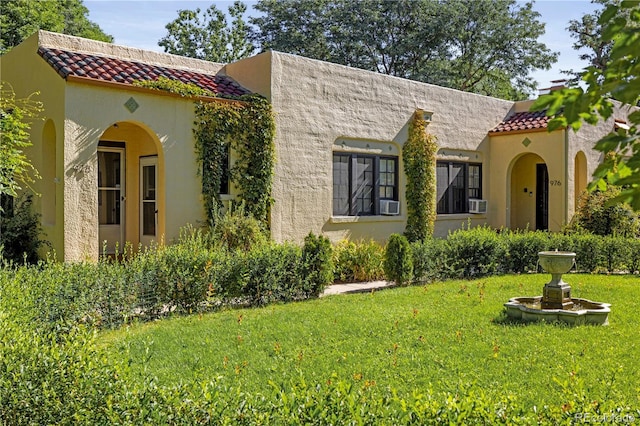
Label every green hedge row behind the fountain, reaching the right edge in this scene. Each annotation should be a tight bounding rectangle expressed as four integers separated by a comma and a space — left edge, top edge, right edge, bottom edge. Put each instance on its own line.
411, 227, 640, 282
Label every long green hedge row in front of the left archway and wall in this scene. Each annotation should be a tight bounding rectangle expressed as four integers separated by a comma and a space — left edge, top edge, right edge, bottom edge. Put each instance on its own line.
0, 230, 333, 327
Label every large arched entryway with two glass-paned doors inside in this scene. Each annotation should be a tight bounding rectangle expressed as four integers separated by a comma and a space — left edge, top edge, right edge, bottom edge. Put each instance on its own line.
97, 122, 164, 254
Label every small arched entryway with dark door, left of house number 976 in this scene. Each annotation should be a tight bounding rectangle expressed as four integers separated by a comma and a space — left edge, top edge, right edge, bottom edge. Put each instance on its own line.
510, 153, 549, 230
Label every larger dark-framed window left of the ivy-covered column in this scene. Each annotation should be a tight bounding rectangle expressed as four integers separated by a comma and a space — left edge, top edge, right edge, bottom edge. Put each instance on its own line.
333, 153, 398, 216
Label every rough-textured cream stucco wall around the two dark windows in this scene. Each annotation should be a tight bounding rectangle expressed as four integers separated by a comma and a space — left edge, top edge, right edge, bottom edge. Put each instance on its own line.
225, 52, 513, 241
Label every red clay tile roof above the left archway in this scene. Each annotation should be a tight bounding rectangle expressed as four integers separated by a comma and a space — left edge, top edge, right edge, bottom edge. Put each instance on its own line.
38, 47, 250, 97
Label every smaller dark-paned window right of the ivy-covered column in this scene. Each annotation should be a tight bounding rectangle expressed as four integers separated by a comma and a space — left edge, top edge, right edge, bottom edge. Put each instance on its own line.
436, 161, 482, 214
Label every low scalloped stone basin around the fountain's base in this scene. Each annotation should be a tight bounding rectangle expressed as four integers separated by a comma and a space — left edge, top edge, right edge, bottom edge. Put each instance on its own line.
504, 296, 611, 325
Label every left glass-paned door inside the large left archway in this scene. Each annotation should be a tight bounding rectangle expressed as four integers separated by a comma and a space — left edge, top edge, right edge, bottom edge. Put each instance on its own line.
98, 147, 125, 254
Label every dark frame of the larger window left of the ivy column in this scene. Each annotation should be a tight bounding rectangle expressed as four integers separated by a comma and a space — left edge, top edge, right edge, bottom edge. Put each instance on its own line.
332, 151, 399, 217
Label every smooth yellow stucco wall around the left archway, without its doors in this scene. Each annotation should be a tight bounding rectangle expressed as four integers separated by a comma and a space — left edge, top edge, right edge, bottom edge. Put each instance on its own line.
65, 83, 203, 259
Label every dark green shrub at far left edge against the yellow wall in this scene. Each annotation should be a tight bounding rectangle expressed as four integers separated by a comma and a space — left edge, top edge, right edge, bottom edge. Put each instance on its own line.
0, 194, 47, 264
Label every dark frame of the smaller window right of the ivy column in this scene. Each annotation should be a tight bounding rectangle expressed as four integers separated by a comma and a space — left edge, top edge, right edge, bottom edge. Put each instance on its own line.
436, 160, 482, 215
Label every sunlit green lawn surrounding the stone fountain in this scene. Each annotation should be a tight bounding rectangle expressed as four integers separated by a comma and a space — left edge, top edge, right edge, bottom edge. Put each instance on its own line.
100, 274, 640, 408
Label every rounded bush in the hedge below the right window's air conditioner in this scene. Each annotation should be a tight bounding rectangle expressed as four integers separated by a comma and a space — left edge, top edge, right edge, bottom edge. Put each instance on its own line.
443, 226, 507, 278
